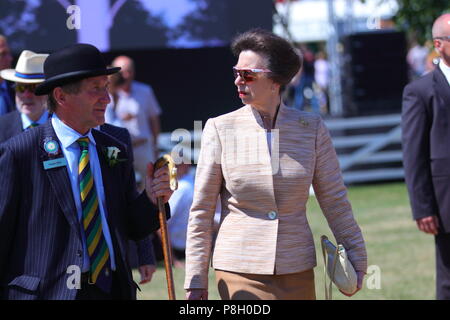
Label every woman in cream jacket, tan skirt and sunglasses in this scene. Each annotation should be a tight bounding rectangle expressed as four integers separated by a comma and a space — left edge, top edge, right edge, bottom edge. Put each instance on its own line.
185, 29, 367, 299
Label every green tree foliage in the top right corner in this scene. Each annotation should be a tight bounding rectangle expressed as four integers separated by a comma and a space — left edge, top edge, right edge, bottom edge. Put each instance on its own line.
394, 0, 450, 44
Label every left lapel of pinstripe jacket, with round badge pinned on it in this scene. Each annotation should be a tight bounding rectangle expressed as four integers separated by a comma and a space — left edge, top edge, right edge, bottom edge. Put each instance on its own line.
39, 120, 81, 239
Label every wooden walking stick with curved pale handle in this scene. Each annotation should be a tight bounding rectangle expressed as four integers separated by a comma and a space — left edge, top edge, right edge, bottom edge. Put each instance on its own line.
155, 154, 178, 300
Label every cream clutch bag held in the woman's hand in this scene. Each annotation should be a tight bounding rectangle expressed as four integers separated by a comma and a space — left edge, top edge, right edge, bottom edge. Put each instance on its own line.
320, 236, 357, 300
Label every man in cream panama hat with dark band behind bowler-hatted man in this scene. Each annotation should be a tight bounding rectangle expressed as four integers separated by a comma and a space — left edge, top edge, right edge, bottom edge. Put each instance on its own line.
0, 50, 48, 142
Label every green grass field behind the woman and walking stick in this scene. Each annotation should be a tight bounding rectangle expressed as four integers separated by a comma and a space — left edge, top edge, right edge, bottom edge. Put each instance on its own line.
134, 183, 435, 300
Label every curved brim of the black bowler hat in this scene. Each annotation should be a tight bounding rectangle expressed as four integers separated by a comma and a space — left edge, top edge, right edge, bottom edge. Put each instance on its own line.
34, 67, 120, 96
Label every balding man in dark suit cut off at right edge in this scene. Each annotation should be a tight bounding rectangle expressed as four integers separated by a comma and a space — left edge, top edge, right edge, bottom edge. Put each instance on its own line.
402, 14, 450, 299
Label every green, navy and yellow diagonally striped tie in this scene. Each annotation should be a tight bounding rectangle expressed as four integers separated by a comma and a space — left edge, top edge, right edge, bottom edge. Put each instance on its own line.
77, 137, 111, 292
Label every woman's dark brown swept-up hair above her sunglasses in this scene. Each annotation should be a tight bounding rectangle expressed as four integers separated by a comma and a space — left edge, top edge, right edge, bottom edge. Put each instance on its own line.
231, 29, 303, 91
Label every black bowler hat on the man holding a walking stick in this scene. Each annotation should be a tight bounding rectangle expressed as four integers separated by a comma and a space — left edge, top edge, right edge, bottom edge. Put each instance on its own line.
34, 43, 120, 96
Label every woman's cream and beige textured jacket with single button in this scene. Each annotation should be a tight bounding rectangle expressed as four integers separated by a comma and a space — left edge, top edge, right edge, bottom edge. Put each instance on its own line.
185, 105, 367, 288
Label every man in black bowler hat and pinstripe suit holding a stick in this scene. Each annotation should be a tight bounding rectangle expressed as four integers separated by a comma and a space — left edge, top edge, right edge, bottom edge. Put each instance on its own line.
0, 44, 172, 300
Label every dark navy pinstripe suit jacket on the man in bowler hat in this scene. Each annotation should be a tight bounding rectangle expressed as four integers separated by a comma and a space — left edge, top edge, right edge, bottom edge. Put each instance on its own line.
0, 121, 164, 299
